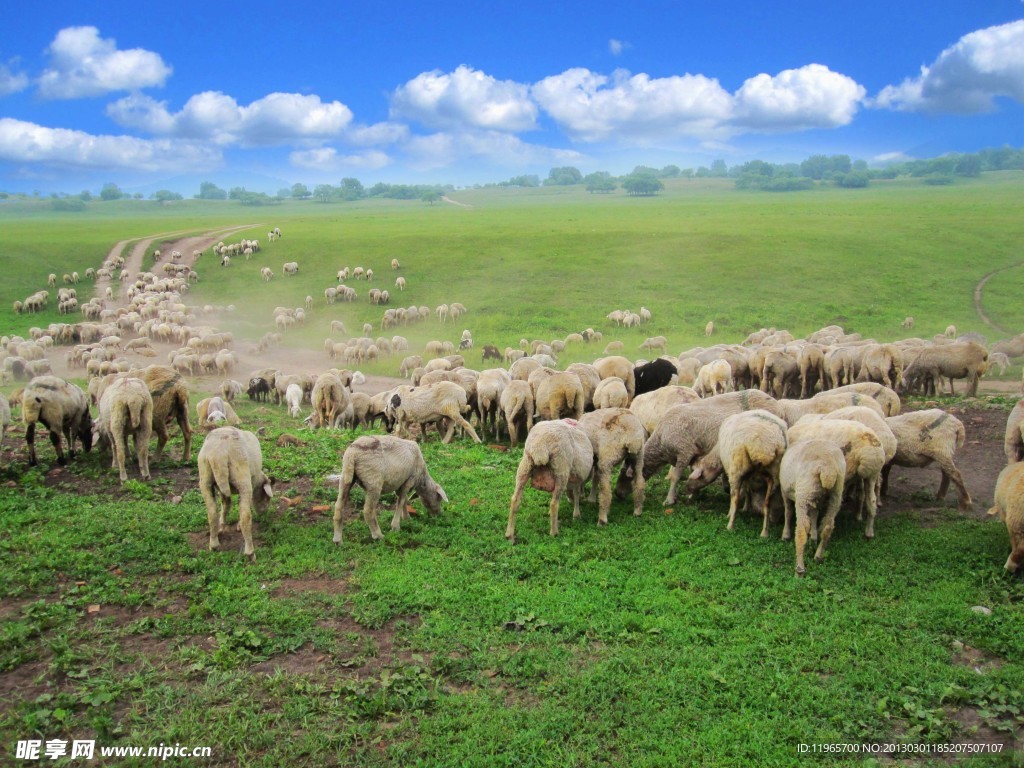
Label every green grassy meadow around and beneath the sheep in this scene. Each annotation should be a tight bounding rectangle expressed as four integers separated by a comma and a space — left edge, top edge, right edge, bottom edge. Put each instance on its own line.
0, 172, 1024, 768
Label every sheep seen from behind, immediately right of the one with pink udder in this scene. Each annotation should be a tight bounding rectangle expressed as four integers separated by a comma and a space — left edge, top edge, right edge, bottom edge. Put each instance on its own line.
579, 408, 647, 525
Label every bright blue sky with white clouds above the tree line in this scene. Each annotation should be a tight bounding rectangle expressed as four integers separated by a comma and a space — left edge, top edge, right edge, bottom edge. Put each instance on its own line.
0, 0, 1024, 195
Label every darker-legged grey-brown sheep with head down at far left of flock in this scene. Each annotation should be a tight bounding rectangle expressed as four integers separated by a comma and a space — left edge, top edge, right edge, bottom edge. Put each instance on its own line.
22, 376, 92, 467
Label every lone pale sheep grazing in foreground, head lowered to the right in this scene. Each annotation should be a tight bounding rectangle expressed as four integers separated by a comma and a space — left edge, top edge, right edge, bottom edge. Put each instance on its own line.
329, 435, 449, 544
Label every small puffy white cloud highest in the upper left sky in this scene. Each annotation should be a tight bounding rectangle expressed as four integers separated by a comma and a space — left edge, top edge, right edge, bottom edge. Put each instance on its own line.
39, 27, 171, 98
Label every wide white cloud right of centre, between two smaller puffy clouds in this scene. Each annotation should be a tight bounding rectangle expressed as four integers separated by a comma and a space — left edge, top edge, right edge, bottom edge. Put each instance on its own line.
530, 68, 732, 143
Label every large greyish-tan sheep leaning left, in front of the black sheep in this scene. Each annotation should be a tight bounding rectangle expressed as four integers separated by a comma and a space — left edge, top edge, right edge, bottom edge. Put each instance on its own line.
643, 389, 782, 507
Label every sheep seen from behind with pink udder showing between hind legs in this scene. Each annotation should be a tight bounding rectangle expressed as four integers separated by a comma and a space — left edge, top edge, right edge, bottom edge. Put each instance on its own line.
505, 419, 594, 543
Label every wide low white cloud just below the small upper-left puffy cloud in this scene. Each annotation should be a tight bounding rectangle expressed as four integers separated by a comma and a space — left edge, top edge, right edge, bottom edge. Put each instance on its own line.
106, 91, 352, 146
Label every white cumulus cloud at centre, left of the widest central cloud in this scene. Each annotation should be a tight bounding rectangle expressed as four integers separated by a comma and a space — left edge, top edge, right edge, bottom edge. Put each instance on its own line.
391, 66, 537, 131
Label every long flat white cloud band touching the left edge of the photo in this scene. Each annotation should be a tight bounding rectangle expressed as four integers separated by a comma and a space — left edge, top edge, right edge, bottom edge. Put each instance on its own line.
0, 118, 222, 172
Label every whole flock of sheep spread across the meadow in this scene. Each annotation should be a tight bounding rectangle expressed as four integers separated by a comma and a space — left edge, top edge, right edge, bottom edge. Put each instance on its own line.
0, 229, 1024, 575
